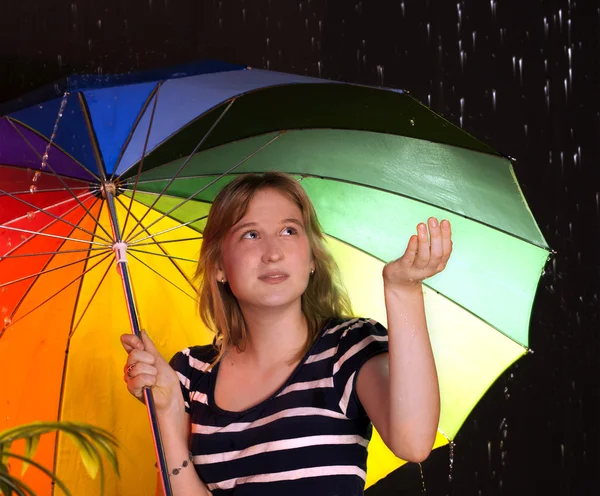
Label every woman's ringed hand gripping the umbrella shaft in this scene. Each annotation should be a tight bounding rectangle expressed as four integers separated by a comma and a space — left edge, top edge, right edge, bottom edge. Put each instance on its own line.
121, 331, 183, 412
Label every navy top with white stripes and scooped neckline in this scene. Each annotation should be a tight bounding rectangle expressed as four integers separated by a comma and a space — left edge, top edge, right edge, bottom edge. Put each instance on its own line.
171, 319, 388, 496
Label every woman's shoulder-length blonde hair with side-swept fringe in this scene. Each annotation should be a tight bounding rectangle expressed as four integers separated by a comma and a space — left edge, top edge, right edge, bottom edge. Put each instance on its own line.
196, 172, 352, 364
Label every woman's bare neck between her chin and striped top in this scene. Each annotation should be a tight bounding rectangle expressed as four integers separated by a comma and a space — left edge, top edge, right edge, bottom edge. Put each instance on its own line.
237, 304, 308, 365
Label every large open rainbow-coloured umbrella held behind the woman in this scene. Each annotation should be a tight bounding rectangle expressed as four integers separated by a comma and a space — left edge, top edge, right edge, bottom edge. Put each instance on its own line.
0, 62, 548, 494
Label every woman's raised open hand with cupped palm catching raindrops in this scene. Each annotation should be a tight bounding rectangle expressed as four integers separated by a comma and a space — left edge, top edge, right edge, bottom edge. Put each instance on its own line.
383, 217, 452, 289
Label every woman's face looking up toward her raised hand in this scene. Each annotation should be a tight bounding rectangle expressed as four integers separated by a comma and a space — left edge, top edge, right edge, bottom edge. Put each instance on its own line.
217, 188, 314, 310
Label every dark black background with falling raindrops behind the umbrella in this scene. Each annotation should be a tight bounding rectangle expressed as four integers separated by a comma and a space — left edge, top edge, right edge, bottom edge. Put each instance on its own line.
0, 0, 600, 496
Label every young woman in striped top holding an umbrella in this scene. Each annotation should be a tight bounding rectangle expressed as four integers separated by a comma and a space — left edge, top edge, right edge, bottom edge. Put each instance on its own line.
121, 172, 452, 496
